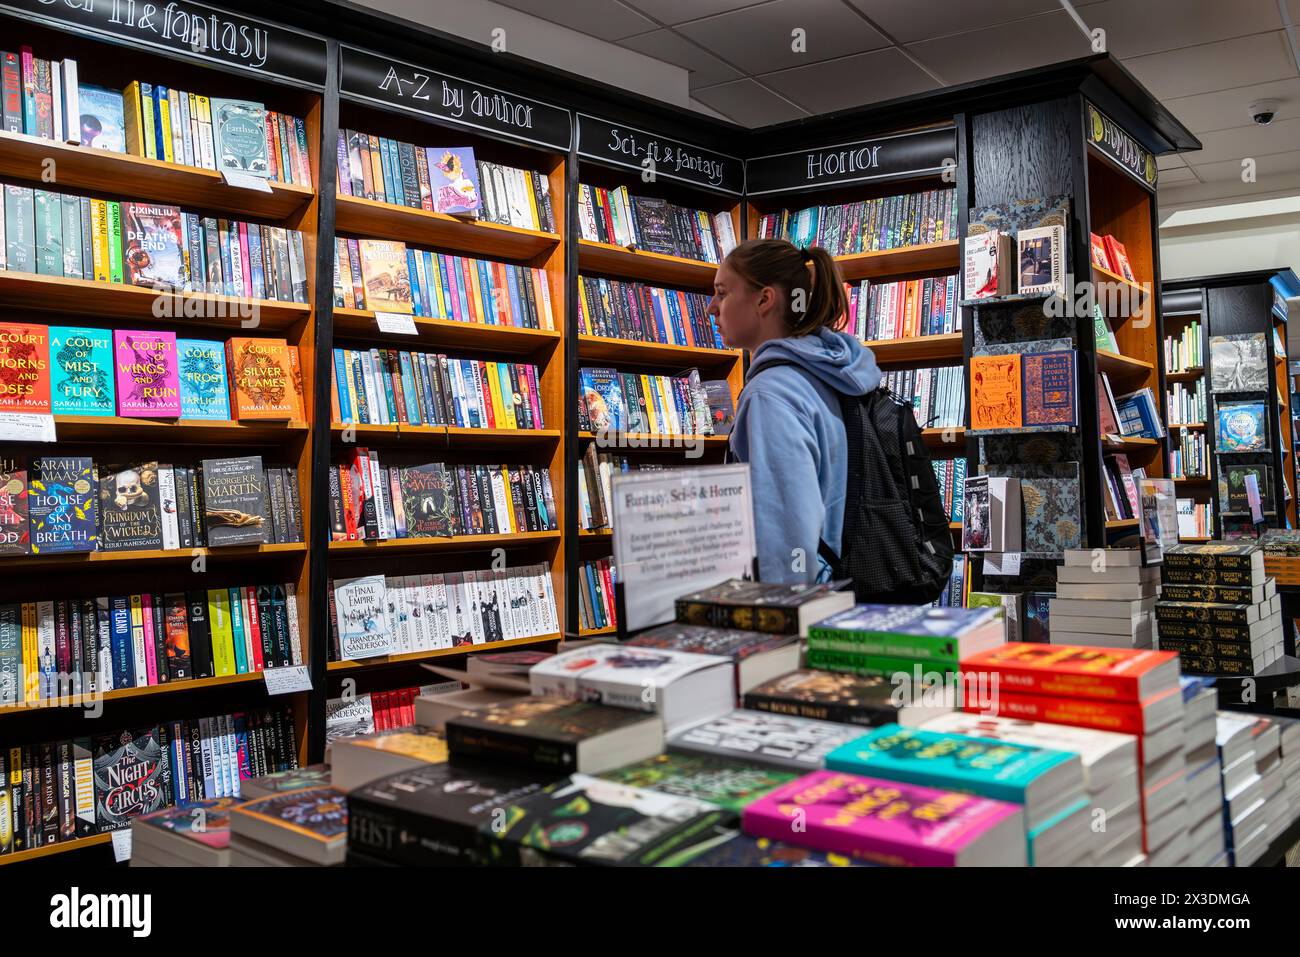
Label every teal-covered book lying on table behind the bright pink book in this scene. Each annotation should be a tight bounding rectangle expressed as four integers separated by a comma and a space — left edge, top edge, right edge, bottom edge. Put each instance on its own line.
826, 724, 1078, 804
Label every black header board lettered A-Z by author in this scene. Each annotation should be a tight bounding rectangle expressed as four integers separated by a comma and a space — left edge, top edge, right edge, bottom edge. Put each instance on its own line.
339, 46, 573, 152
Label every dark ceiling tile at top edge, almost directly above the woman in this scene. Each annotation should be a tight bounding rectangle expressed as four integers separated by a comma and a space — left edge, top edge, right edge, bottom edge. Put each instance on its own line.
677, 0, 889, 75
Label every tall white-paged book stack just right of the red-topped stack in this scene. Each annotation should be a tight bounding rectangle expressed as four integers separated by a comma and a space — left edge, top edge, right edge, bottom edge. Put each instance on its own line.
1180, 676, 1227, 867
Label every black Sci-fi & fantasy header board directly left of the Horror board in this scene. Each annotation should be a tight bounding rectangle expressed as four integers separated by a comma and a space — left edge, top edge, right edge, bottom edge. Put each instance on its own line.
577, 113, 745, 196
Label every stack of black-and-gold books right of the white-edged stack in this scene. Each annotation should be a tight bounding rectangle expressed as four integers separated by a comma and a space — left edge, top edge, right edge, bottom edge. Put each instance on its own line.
1156, 542, 1283, 676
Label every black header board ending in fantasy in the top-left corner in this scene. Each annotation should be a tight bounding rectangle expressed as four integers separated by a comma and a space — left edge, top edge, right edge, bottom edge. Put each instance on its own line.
0, 0, 326, 87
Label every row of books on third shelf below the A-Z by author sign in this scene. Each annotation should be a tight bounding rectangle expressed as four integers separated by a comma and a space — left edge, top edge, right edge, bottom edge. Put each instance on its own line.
330, 348, 546, 429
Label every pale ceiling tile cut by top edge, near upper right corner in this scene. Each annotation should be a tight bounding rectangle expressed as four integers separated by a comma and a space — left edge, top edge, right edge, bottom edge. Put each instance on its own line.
1082, 0, 1282, 57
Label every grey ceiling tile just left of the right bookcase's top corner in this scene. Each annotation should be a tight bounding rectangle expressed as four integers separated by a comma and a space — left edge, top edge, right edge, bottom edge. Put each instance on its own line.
907, 10, 1091, 83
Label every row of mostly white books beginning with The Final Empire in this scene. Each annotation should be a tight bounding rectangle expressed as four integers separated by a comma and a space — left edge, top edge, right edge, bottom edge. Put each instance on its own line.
330, 562, 560, 661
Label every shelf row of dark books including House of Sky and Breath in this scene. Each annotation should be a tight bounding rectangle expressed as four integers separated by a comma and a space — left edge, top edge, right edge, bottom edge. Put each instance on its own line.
0, 455, 303, 555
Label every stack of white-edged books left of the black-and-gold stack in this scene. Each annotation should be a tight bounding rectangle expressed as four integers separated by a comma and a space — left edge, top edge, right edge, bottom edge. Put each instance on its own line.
1048, 549, 1160, 648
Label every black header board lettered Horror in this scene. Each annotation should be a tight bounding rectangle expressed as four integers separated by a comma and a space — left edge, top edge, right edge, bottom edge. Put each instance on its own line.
745, 126, 957, 196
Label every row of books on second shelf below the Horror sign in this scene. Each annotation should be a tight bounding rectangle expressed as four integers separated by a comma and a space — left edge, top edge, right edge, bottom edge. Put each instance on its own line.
845, 274, 962, 342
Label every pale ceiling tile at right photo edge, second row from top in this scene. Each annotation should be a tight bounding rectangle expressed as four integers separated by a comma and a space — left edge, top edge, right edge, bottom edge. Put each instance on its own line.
1125, 30, 1296, 100
